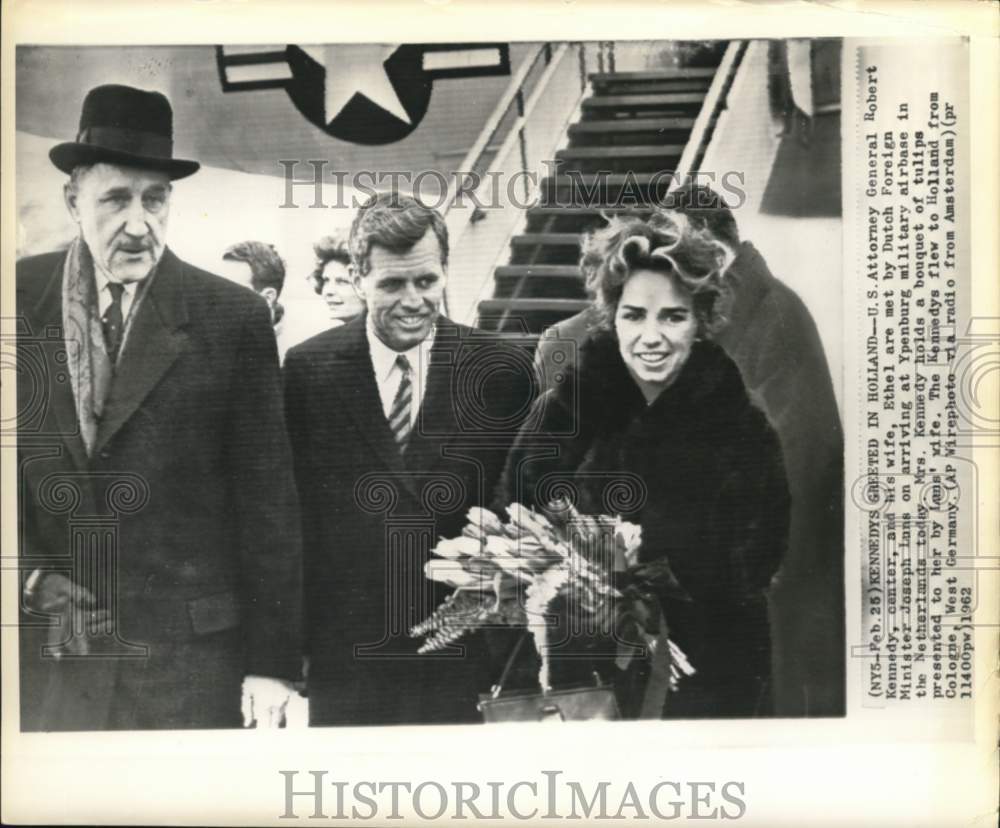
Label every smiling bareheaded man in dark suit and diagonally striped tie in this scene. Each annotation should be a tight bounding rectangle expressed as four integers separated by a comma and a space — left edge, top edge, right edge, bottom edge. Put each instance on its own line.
285, 193, 534, 725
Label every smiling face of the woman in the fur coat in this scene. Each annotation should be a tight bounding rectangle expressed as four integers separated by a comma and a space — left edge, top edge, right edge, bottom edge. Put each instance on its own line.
615, 269, 698, 402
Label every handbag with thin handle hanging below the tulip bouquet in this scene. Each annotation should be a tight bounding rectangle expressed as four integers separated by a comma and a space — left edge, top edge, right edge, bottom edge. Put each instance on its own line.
477, 632, 621, 722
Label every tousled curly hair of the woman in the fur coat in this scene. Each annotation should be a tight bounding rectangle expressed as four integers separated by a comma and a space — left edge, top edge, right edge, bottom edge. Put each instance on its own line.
580, 211, 731, 336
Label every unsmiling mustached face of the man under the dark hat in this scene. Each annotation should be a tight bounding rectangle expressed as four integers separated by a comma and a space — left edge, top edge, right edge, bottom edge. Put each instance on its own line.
65, 164, 170, 282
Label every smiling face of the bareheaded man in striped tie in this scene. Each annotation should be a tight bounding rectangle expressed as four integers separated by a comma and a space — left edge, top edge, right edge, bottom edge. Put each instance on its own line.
354, 230, 447, 352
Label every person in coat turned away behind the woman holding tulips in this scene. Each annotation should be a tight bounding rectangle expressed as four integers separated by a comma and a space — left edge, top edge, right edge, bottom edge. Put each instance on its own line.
667, 184, 845, 716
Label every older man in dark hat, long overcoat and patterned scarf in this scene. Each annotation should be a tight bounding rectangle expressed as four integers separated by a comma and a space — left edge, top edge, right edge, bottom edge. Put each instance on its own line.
17, 86, 301, 730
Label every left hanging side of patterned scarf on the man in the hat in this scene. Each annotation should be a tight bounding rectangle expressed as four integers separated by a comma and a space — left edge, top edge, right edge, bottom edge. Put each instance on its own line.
62, 238, 114, 456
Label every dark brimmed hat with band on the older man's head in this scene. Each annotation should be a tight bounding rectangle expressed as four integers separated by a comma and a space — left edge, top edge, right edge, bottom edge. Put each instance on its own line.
49, 84, 201, 179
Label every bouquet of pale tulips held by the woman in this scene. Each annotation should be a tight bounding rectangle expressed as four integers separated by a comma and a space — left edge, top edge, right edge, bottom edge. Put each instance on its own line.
410, 501, 694, 704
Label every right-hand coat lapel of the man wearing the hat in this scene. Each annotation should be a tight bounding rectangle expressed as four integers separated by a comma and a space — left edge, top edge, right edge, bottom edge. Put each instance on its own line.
94, 250, 188, 452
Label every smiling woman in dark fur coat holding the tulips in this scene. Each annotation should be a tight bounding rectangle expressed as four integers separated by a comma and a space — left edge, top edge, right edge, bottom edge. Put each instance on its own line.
497, 213, 789, 718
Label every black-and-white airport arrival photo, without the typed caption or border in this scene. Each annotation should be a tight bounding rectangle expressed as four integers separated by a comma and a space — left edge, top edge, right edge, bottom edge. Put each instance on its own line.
17, 39, 844, 731
